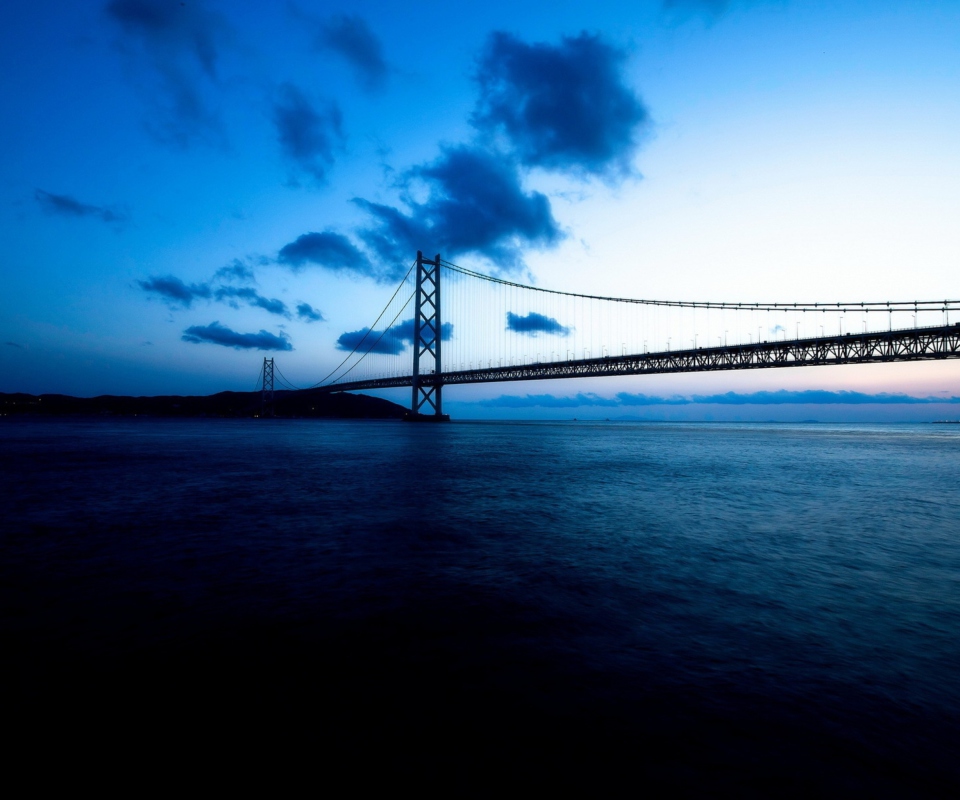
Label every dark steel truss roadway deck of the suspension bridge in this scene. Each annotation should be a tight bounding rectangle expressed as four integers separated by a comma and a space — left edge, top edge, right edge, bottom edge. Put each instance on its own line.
311, 323, 960, 392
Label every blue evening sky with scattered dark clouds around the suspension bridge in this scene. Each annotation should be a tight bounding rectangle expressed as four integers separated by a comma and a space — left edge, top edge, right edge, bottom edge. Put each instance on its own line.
0, 0, 960, 418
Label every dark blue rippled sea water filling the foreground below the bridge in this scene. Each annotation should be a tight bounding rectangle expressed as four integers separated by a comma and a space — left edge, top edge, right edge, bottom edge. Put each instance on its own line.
0, 419, 960, 796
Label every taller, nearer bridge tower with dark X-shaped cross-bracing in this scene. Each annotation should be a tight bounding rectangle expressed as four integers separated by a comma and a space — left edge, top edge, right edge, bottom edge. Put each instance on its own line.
406, 250, 450, 422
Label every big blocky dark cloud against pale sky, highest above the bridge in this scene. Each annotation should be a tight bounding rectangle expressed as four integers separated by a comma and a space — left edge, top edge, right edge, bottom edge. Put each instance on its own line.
472, 32, 649, 176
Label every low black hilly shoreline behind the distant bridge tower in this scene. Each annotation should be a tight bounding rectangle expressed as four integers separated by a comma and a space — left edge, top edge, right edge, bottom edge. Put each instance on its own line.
0, 389, 405, 419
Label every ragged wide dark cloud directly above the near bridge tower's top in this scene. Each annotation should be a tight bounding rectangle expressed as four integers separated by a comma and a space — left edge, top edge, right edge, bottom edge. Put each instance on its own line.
354, 146, 563, 275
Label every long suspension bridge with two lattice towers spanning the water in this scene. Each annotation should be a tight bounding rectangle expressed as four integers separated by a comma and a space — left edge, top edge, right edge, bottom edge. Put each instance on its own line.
258, 252, 960, 421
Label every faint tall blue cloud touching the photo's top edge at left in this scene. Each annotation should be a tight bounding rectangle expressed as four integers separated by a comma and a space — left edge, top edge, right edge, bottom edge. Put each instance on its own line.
105, 0, 226, 147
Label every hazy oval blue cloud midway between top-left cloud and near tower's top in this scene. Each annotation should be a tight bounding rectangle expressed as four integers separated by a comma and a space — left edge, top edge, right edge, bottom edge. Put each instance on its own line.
273, 83, 344, 183
